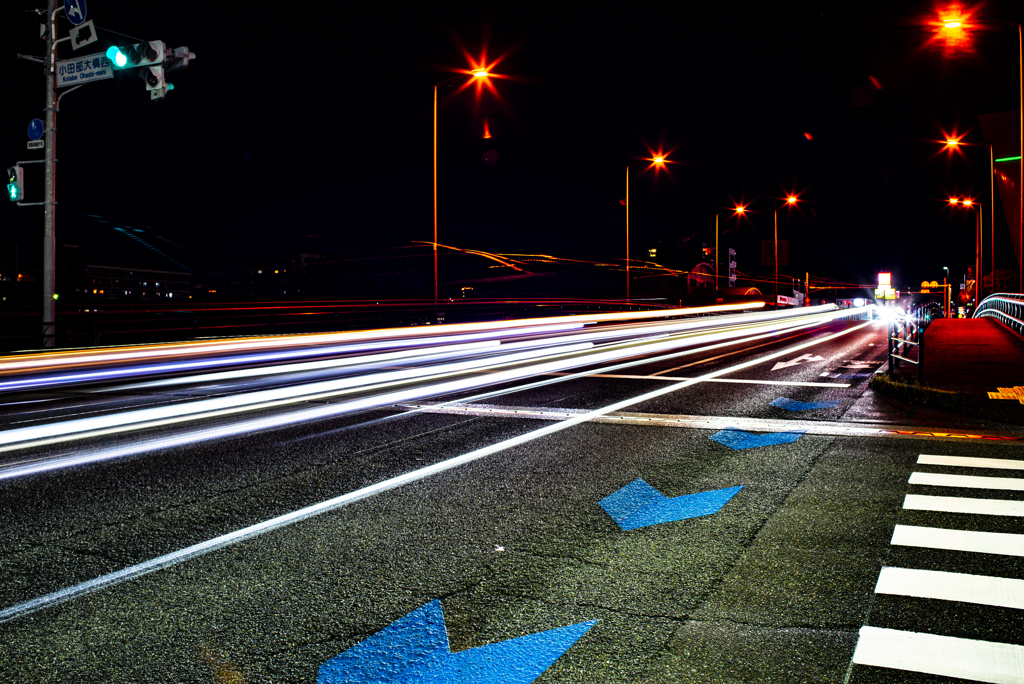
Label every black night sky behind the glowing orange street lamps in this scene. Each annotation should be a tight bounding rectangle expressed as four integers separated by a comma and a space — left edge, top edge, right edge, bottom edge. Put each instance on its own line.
0, 0, 1024, 294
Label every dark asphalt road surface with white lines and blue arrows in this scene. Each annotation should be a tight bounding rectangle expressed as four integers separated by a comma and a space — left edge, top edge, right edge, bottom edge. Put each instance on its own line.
0, 307, 1024, 684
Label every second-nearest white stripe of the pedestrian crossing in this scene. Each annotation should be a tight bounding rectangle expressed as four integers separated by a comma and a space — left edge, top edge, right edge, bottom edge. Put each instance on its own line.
874, 567, 1024, 609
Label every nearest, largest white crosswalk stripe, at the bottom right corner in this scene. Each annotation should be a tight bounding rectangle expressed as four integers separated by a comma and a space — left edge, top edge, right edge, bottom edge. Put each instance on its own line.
853, 627, 1024, 684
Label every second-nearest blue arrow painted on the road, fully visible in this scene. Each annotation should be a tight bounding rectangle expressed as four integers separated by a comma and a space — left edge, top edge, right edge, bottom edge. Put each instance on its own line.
599, 478, 743, 529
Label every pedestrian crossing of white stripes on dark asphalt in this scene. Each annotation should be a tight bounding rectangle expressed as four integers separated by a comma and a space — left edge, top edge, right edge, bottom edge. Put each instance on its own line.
849, 455, 1024, 684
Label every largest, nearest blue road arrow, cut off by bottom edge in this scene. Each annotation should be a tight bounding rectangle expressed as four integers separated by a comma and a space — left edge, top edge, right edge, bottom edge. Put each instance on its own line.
316, 600, 597, 684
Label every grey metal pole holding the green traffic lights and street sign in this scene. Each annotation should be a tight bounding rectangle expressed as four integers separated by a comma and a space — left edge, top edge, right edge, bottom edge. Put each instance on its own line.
42, 0, 62, 348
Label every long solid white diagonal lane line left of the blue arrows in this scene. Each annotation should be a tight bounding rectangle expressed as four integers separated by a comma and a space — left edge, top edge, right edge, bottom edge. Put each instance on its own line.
0, 322, 870, 623
